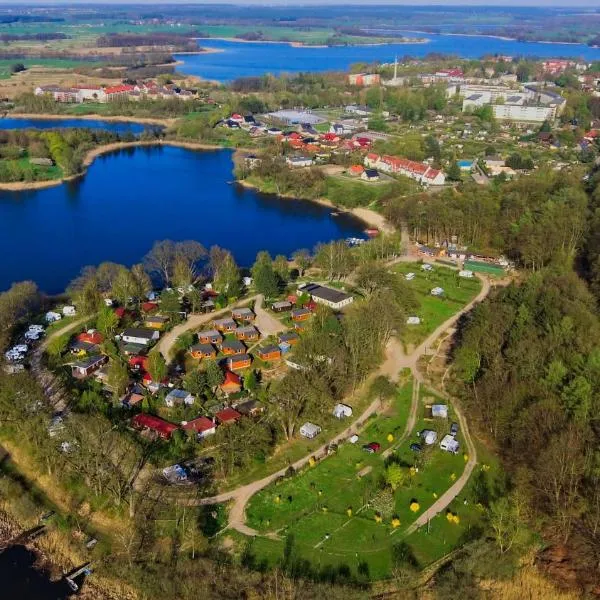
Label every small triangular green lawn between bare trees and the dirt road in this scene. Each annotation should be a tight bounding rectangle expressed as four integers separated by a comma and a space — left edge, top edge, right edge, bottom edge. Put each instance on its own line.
394, 263, 481, 347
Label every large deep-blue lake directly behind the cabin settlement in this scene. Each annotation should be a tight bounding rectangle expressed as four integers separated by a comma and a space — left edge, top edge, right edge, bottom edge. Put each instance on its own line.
0, 146, 365, 293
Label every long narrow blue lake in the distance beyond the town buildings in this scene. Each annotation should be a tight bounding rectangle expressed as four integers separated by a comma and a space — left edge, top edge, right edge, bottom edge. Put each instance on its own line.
176, 31, 600, 81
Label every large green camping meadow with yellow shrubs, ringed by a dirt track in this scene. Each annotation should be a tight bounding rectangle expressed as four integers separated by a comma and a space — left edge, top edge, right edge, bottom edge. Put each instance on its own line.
238, 382, 481, 580
